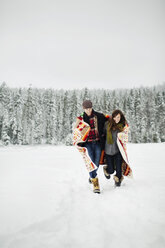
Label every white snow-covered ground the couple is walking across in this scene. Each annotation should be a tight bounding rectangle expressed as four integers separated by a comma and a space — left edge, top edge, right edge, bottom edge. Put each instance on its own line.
0, 143, 165, 248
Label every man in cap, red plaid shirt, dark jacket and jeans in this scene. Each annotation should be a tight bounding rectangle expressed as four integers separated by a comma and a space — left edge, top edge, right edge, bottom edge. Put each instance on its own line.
79, 100, 107, 193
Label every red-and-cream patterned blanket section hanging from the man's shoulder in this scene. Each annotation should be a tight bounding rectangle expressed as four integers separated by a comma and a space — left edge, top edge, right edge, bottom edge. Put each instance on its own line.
73, 116, 97, 172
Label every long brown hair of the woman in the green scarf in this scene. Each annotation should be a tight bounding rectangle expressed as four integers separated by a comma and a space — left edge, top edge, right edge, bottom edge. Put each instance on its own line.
109, 109, 127, 130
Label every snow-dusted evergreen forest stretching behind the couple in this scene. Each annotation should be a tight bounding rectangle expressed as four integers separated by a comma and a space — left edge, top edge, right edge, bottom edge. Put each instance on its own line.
0, 82, 165, 145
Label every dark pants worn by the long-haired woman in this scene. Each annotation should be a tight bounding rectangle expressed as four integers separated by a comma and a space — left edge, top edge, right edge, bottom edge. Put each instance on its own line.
105, 152, 123, 179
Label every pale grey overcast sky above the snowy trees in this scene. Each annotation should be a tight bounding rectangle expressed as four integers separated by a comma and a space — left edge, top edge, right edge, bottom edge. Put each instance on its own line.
0, 0, 165, 89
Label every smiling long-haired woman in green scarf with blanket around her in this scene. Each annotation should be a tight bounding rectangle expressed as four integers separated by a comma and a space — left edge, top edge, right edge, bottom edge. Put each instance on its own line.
103, 109, 132, 186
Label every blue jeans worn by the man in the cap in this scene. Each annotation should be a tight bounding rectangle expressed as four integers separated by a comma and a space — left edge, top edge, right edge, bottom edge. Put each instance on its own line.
84, 142, 101, 178
